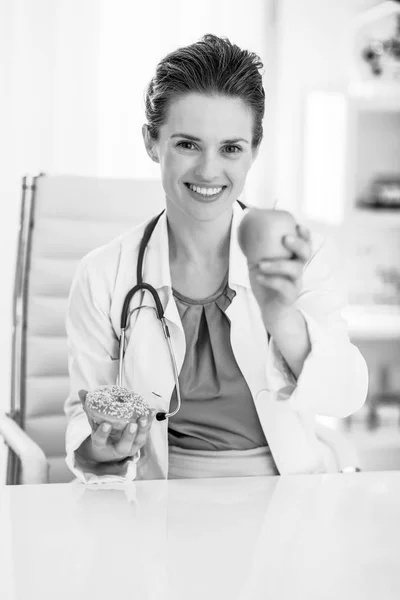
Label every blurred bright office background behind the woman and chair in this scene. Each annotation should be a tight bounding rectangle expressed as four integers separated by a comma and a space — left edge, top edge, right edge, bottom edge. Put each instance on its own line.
0, 0, 400, 470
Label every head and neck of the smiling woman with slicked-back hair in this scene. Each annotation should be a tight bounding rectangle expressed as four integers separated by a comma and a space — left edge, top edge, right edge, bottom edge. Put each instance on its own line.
142, 35, 265, 299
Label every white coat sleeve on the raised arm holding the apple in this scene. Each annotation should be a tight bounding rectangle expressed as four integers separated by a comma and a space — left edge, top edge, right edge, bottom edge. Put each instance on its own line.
270, 235, 368, 418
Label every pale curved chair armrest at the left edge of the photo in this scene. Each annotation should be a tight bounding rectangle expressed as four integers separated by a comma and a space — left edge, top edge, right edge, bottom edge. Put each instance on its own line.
0, 413, 49, 484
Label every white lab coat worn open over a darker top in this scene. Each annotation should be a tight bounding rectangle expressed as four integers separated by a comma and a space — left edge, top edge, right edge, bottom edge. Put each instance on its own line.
65, 203, 368, 483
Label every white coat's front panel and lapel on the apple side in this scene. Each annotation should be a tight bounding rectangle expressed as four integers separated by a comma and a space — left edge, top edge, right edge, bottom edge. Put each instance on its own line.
226, 210, 321, 474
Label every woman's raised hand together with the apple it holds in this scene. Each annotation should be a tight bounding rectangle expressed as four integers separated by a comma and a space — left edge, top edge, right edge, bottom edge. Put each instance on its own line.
238, 208, 311, 328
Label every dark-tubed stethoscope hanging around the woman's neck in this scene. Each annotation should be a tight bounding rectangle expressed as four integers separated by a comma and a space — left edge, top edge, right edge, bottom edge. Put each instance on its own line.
117, 200, 247, 421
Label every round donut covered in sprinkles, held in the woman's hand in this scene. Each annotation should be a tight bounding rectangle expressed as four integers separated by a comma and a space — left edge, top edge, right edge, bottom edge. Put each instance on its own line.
85, 385, 150, 431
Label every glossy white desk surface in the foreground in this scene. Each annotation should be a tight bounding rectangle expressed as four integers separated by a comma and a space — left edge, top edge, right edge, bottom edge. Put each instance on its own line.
0, 472, 400, 600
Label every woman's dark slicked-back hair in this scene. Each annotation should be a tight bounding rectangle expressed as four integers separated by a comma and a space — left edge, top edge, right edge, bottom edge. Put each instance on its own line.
145, 33, 265, 149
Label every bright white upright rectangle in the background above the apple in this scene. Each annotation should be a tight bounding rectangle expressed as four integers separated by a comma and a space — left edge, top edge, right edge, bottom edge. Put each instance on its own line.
303, 91, 346, 225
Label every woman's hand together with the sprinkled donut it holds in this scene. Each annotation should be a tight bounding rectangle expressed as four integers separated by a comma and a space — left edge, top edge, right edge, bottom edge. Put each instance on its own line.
78, 386, 156, 463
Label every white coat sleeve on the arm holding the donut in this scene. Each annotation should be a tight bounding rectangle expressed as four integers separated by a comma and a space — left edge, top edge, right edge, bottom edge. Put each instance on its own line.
64, 257, 140, 483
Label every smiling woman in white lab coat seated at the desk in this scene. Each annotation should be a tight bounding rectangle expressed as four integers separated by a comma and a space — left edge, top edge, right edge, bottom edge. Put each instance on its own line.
65, 35, 367, 482
